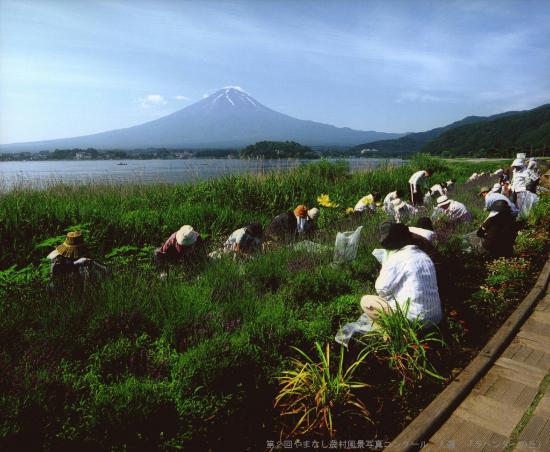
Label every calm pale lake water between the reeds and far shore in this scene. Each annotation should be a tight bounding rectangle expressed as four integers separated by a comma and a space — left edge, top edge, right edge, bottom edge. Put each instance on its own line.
0, 158, 403, 189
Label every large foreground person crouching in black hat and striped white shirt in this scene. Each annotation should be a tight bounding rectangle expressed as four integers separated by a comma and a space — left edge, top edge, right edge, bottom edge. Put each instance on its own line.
361, 222, 442, 324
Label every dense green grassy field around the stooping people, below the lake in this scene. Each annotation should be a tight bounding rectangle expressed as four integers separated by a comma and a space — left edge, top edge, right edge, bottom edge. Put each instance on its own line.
0, 157, 547, 450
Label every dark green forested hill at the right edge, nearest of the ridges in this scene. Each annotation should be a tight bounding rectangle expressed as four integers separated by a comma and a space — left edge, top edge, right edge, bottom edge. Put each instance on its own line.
422, 104, 550, 157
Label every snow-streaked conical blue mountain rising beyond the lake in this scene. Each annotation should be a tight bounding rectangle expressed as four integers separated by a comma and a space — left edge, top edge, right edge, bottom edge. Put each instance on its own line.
0, 87, 403, 152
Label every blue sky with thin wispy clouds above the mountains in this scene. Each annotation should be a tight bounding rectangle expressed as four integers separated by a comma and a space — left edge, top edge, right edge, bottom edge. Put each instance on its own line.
0, 0, 550, 143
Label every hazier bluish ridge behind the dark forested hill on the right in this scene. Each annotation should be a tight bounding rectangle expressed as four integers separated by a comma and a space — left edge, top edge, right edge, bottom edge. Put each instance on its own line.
355, 111, 532, 154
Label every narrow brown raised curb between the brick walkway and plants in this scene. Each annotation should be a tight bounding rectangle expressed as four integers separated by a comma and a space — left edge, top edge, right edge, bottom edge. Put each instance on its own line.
384, 259, 550, 452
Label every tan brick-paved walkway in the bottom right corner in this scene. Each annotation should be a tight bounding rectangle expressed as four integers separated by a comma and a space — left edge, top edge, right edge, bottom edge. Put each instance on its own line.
422, 287, 550, 452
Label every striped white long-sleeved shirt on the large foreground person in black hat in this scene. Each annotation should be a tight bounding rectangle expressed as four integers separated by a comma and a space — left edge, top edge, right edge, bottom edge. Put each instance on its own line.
375, 245, 442, 323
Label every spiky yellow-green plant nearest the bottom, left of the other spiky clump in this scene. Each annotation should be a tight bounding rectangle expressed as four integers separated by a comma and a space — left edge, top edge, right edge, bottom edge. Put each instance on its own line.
275, 342, 370, 438
